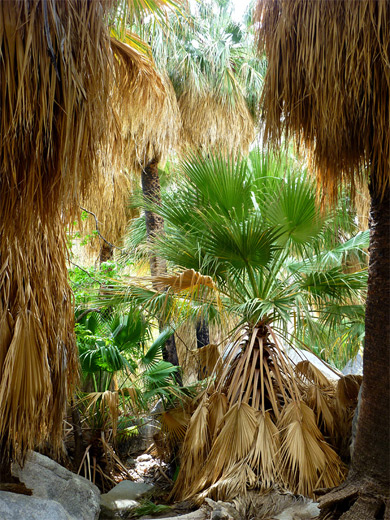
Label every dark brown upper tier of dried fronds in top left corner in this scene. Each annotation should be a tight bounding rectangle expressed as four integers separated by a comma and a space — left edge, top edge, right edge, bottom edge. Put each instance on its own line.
0, 1, 111, 230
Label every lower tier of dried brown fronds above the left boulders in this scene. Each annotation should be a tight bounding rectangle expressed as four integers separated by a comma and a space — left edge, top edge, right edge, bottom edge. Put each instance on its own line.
0, 223, 77, 453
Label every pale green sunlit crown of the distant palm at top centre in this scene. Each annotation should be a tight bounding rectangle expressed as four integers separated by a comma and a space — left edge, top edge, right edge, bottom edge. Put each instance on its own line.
134, 1, 265, 119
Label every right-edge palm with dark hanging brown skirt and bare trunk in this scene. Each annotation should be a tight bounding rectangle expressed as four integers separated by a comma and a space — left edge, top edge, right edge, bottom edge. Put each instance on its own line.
258, 0, 390, 519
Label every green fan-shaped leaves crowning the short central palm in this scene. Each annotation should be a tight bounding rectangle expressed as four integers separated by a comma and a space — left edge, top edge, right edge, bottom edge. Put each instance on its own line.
125, 151, 368, 367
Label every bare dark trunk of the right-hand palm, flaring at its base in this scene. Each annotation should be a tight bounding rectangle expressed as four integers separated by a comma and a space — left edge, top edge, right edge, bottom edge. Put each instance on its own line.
321, 176, 390, 520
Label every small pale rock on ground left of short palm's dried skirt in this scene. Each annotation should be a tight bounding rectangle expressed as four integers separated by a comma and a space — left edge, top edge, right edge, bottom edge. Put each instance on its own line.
100, 480, 153, 518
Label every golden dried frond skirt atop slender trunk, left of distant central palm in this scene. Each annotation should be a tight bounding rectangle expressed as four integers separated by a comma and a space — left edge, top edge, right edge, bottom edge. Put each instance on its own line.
111, 38, 181, 171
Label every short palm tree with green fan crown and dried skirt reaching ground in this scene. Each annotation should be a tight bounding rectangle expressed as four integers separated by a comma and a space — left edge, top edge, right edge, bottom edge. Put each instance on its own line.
114, 153, 367, 500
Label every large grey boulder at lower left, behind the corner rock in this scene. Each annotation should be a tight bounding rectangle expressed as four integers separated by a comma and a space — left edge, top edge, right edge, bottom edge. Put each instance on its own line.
11, 452, 100, 520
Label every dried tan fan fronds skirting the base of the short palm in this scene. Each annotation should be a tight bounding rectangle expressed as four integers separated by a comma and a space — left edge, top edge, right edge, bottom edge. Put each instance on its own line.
173, 330, 344, 502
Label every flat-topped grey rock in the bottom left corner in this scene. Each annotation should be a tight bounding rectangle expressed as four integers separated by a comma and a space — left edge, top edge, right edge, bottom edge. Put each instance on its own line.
0, 491, 72, 520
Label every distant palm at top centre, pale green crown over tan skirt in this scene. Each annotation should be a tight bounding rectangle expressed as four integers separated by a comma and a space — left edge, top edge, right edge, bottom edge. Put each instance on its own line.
141, 1, 264, 153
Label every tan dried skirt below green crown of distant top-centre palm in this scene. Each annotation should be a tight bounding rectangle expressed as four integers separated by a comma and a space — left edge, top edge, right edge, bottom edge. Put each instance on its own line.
179, 90, 255, 154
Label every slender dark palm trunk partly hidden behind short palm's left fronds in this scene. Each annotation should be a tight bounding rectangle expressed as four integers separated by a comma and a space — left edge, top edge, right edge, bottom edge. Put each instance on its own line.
141, 159, 181, 374
